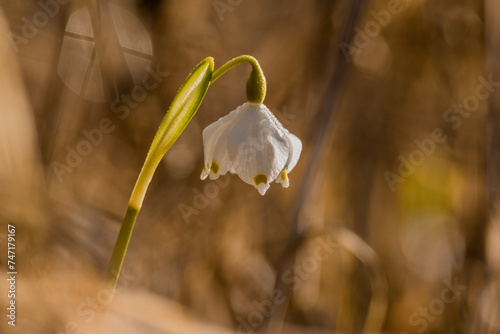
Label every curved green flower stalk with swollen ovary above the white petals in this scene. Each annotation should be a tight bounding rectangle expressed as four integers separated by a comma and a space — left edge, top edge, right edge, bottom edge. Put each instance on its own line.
210, 55, 267, 104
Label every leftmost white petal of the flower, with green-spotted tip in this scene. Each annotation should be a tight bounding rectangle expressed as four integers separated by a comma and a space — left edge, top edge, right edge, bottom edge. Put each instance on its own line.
201, 107, 241, 180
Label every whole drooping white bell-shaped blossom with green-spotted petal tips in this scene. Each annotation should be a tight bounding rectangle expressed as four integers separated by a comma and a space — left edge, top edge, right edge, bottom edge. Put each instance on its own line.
201, 103, 302, 195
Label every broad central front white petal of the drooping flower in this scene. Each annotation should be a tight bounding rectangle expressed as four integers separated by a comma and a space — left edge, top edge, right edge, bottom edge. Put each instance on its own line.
227, 103, 289, 189
